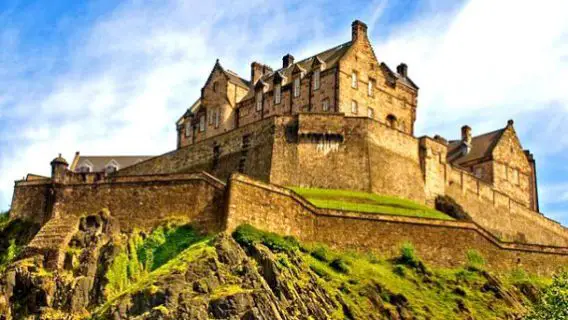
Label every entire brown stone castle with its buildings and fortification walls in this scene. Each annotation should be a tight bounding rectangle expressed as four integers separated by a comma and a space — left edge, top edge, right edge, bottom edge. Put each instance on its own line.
7, 21, 568, 273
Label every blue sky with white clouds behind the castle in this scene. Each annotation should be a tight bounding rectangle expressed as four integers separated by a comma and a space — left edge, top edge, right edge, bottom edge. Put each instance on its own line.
0, 0, 568, 225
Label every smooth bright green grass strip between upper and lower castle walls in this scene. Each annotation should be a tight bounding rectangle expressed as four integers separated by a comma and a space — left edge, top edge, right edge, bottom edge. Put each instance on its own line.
290, 187, 454, 220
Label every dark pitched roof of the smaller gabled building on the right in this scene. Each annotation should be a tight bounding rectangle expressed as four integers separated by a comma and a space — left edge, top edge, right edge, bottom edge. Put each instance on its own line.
447, 128, 506, 165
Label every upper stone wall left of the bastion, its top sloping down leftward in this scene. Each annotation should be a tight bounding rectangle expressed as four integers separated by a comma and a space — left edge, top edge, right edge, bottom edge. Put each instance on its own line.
118, 117, 275, 181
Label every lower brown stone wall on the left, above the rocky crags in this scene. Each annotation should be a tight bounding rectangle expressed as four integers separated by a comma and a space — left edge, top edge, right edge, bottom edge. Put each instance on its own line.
12, 173, 225, 231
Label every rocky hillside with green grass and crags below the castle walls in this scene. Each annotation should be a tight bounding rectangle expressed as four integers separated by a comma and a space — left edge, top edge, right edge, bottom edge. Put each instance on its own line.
0, 214, 548, 319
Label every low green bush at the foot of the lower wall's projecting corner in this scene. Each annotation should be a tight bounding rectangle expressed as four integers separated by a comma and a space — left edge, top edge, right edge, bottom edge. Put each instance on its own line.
233, 224, 299, 252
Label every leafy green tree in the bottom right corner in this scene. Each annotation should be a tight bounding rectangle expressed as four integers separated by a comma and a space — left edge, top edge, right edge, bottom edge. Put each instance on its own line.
526, 271, 568, 320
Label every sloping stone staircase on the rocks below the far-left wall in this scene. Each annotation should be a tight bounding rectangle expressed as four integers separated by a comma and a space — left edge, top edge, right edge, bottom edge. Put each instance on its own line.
23, 215, 79, 269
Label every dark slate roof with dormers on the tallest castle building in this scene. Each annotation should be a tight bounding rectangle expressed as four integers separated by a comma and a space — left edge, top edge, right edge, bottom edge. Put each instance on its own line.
237, 41, 351, 101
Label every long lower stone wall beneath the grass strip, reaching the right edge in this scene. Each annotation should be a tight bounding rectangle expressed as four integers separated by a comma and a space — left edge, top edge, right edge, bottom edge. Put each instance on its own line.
226, 175, 568, 274
